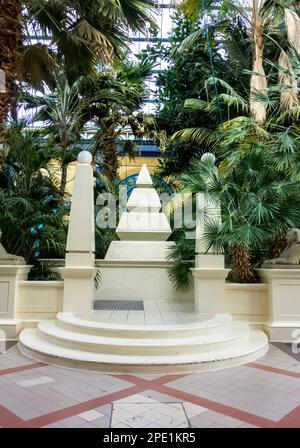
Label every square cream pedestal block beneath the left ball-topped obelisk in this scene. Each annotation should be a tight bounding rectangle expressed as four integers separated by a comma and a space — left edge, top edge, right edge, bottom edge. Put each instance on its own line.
60, 267, 97, 313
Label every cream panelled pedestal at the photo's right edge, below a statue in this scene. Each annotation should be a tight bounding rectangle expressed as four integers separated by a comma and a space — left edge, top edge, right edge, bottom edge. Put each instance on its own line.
258, 269, 300, 342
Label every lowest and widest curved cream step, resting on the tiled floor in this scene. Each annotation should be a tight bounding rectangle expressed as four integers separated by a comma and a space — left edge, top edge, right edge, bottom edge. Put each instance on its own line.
19, 329, 268, 374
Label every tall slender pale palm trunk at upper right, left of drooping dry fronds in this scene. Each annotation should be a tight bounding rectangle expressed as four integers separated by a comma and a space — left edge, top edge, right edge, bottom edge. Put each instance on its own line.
250, 0, 267, 123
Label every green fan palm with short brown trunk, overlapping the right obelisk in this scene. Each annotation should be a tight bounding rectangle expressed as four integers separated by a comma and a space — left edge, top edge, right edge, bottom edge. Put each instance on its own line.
181, 150, 300, 283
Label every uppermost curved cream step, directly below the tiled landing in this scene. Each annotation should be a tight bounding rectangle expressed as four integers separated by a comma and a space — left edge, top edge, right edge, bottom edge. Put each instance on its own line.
56, 313, 232, 339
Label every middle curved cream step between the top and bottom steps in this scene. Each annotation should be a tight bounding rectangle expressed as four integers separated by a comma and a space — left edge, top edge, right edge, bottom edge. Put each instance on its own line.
38, 320, 250, 356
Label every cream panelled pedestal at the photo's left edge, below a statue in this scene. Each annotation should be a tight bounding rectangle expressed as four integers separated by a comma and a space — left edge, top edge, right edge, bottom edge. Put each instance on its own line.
0, 265, 32, 339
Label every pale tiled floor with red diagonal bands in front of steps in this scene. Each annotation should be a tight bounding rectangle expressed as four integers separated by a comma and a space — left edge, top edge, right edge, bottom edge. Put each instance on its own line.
0, 344, 300, 428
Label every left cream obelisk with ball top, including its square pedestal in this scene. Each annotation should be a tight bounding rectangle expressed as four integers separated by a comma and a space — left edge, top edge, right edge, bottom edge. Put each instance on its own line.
61, 151, 97, 313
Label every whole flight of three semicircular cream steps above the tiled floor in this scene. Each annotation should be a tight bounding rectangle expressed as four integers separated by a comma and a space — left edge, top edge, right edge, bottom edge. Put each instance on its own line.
19, 313, 268, 374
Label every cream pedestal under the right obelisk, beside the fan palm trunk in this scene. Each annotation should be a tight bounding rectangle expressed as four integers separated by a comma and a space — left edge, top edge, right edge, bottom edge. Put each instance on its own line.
192, 268, 229, 314
